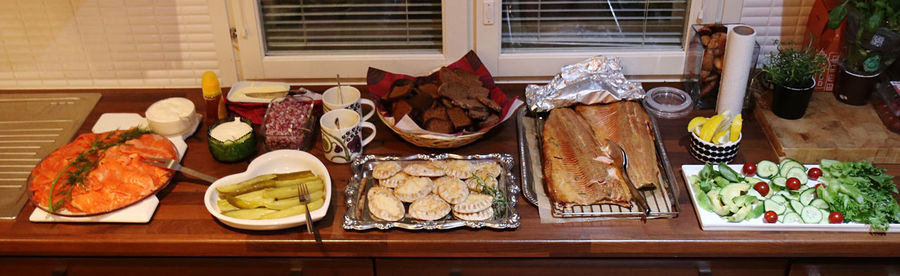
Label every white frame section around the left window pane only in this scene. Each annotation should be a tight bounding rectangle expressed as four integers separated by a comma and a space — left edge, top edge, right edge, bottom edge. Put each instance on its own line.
230, 0, 472, 80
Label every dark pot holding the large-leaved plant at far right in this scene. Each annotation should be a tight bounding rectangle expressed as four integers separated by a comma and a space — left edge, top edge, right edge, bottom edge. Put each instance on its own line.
832, 62, 881, 105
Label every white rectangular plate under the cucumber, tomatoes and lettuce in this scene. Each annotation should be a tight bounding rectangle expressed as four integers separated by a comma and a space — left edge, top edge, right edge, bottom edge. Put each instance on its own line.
681, 164, 900, 233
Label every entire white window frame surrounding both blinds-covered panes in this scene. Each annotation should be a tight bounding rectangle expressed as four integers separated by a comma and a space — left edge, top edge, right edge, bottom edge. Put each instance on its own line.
220, 0, 745, 84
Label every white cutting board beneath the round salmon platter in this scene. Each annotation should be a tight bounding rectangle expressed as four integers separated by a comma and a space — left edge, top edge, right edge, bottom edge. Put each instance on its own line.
28, 113, 193, 223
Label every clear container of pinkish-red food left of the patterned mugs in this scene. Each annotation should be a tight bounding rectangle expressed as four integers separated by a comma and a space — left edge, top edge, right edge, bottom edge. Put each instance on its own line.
261, 95, 315, 151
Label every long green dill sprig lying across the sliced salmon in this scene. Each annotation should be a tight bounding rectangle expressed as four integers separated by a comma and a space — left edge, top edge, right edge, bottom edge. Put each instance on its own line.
47, 127, 152, 212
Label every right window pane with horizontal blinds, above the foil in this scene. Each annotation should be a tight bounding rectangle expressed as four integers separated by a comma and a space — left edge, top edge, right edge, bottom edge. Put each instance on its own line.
501, 0, 689, 53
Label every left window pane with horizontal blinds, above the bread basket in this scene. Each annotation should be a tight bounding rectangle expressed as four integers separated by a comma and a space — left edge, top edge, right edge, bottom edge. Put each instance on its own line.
259, 0, 443, 56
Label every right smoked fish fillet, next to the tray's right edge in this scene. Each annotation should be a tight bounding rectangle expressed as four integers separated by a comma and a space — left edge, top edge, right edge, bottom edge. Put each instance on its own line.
575, 101, 659, 189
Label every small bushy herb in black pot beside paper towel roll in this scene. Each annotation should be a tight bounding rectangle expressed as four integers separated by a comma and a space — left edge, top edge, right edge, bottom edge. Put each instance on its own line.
762, 41, 828, 120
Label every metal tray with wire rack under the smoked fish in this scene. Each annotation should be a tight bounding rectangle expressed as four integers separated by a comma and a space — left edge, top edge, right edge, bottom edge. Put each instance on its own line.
516, 104, 679, 218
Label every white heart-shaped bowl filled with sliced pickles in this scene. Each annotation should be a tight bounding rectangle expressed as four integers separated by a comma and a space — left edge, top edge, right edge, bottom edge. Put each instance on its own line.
204, 150, 332, 230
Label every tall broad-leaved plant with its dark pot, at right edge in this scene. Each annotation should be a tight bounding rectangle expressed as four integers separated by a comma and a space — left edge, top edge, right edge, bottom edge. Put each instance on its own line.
828, 0, 900, 105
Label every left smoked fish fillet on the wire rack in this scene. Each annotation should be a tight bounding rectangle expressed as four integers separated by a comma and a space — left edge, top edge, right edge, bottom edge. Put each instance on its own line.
542, 108, 631, 208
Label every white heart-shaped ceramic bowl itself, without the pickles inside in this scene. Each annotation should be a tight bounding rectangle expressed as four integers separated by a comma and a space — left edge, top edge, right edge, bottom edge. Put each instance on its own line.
203, 150, 333, 230
